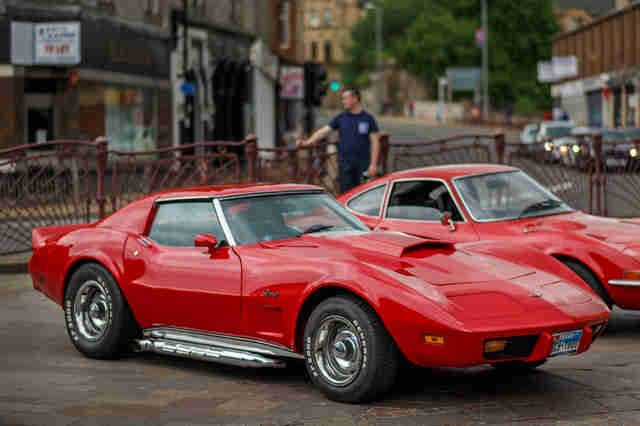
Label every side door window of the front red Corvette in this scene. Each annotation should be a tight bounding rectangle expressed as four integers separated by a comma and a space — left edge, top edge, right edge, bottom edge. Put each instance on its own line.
149, 200, 226, 247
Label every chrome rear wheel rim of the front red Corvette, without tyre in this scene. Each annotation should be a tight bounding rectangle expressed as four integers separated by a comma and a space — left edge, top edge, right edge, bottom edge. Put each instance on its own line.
73, 280, 111, 341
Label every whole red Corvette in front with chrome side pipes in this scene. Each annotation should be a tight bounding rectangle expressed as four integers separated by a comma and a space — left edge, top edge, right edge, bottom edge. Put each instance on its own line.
29, 185, 609, 402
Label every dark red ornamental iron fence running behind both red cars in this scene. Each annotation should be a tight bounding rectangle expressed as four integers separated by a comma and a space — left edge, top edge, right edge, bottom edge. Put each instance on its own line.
0, 133, 640, 255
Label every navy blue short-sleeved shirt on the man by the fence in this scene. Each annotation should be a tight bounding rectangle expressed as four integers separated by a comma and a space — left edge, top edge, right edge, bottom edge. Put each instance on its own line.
329, 110, 378, 164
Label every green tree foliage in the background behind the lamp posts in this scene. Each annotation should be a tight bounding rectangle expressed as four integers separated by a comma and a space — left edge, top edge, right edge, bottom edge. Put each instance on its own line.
343, 0, 558, 108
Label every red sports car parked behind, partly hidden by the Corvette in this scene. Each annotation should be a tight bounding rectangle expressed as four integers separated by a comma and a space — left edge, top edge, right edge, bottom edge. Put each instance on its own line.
338, 164, 640, 309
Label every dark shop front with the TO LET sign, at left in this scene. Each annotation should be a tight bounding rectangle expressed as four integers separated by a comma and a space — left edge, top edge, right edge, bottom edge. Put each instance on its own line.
0, 11, 172, 151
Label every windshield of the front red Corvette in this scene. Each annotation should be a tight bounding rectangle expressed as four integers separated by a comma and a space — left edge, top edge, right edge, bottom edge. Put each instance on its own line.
221, 193, 368, 245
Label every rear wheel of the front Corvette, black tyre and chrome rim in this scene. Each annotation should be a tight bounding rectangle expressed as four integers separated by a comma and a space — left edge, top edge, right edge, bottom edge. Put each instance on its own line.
64, 263, 139, 359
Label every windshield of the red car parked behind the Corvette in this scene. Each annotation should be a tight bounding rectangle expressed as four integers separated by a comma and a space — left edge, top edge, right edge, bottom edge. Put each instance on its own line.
453, 171, 572, 222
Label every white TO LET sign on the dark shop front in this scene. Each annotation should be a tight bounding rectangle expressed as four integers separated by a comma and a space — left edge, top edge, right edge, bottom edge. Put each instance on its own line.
34, 22, 80, 65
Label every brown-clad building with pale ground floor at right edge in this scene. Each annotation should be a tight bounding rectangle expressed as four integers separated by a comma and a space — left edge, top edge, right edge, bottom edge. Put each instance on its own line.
552, 3, 640, 127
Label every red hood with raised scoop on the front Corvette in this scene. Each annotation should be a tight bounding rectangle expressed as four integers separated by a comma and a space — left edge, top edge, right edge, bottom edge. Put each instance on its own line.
255, 231, 606, 321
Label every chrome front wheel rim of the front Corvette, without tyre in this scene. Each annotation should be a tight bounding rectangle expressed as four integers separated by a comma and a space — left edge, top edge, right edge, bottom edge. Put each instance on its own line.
313, 315, 363, 386
